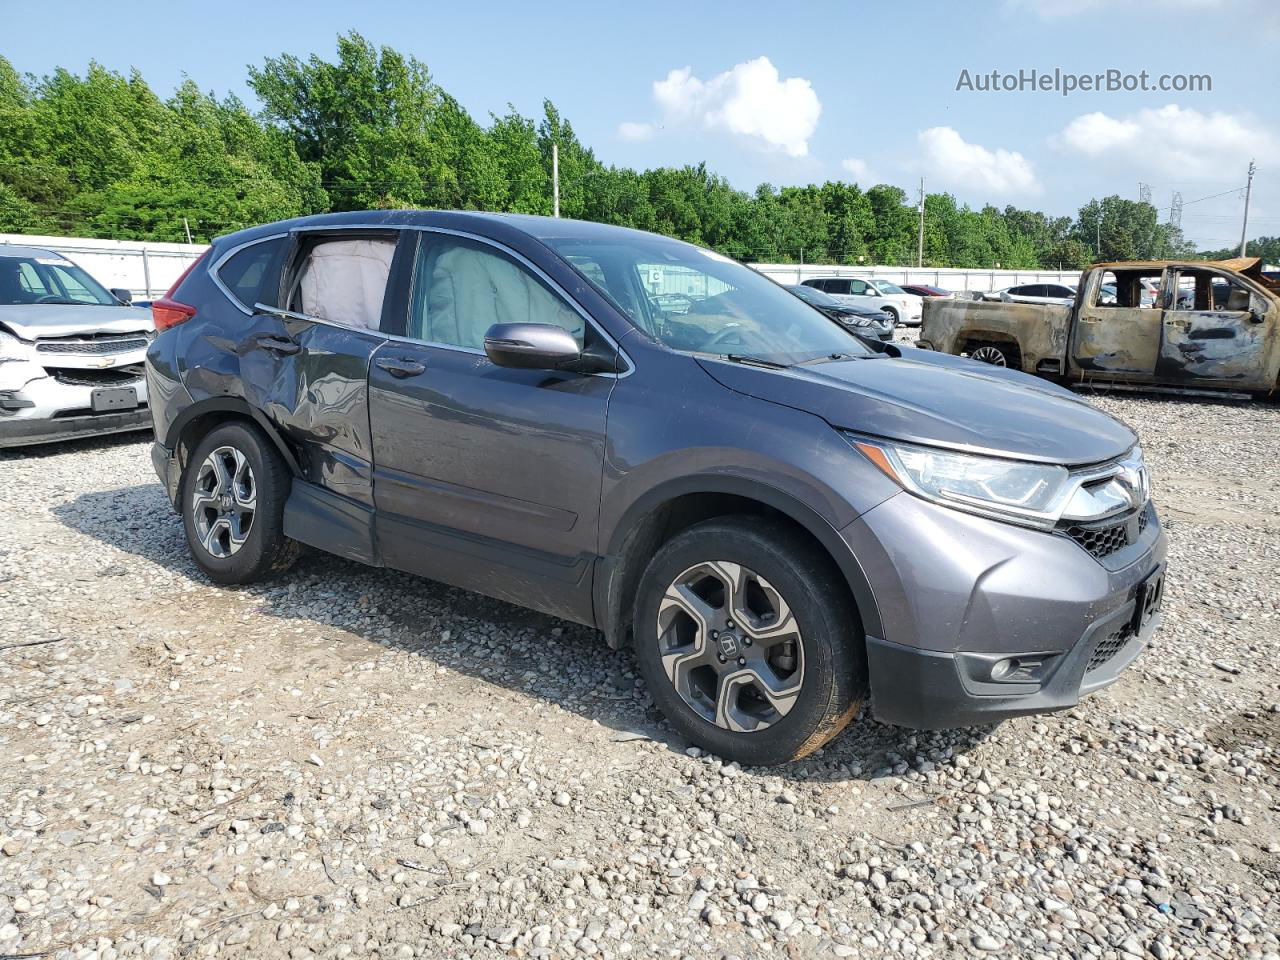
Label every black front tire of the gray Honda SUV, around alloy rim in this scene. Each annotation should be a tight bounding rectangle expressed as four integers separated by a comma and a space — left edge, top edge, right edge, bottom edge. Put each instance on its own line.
632, 516, 867, 765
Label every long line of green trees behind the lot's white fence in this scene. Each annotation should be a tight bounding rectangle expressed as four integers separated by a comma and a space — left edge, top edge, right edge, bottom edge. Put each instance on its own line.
0, 32, 1218, 269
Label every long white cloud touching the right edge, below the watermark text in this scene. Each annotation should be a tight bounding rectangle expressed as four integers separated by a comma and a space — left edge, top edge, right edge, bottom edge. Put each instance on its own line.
1057, 104, 1280, 180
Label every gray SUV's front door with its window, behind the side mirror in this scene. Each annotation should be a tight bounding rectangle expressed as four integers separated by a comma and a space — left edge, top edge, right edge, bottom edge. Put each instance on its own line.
369, 232, 616, 622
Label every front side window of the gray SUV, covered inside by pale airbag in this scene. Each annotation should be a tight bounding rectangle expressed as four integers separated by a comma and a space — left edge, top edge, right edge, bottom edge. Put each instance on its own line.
424, 246, 582, 348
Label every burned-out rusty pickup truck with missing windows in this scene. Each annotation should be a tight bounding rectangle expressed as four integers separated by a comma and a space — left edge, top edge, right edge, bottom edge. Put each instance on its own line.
918, 257, 1280, 396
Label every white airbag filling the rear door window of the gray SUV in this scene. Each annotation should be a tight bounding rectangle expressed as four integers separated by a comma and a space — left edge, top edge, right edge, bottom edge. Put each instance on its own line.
302, 239, 396, 330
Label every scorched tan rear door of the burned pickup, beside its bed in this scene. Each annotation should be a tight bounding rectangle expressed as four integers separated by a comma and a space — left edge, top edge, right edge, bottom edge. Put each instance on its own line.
1071, 270, 1164, 383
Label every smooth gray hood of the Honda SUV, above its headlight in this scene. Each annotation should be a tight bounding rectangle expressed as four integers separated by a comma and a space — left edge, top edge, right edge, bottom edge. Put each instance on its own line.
698, 347, 1138, 465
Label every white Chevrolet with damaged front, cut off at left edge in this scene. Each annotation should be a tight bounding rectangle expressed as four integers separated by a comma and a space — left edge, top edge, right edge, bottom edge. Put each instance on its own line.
0, 246, 155, 448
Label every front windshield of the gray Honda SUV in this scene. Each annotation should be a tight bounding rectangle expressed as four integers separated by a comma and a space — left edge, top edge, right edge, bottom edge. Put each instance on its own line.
545, 234, 874, 364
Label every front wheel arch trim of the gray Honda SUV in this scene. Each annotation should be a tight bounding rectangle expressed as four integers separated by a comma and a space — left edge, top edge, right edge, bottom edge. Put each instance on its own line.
594, 475, 883, 649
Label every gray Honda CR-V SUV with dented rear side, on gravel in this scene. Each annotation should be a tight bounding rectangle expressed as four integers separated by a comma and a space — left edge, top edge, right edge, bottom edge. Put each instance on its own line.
147, 211, 1165, 763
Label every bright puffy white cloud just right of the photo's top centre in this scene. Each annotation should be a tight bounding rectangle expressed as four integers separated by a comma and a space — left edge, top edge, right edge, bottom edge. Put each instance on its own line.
653, 56, 822, 156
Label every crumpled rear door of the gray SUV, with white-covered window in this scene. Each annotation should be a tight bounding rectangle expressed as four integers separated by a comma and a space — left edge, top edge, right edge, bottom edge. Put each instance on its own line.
228, 230, 401, 507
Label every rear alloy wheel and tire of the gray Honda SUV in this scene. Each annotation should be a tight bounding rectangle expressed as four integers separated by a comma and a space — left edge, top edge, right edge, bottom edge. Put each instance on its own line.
179, 424, 300, 584
